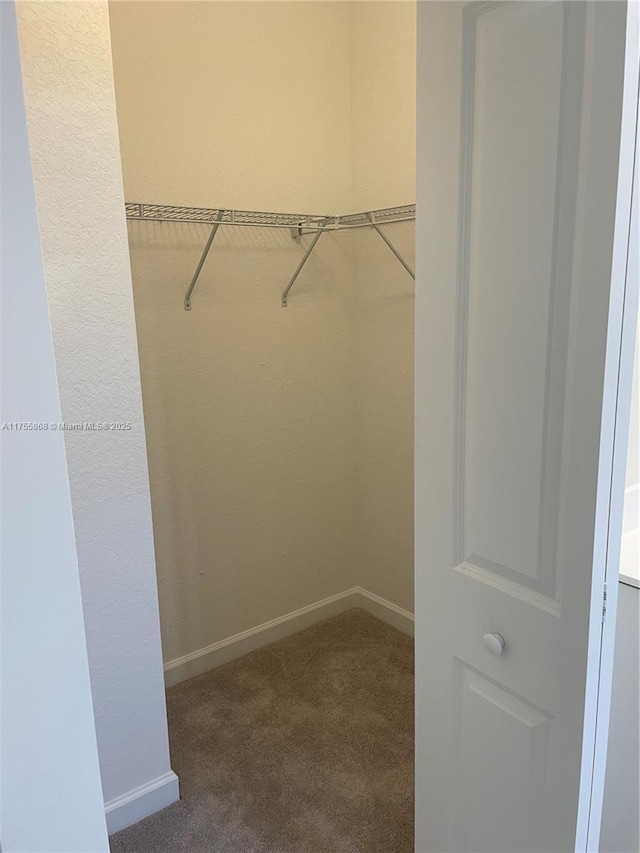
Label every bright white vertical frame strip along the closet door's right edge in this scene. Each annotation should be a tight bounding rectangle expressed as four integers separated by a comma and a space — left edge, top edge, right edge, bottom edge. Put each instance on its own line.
576, 0, 640, 853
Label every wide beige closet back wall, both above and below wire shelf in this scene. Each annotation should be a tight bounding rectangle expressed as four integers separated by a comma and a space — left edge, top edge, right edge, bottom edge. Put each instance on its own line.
110, 2, 357, 660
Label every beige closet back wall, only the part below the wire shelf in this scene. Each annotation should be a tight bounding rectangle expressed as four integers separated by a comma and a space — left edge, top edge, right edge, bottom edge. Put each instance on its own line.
129, 222, 357, 660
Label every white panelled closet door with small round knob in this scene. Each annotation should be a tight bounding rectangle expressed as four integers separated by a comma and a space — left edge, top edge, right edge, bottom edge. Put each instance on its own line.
416, 2, 638, 853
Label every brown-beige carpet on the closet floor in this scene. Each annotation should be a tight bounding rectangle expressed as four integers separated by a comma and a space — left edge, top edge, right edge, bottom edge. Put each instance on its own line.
111, 610, 413, 853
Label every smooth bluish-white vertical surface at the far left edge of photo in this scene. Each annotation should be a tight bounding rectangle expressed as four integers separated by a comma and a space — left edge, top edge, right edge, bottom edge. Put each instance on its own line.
0, 2, 109, 853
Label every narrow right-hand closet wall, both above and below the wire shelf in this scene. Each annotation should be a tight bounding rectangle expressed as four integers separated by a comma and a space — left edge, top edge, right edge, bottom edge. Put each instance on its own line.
349, 0, 416, 611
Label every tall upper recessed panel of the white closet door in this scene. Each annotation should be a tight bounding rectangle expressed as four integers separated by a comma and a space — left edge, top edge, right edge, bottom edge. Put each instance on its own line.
455, 3, 568, 596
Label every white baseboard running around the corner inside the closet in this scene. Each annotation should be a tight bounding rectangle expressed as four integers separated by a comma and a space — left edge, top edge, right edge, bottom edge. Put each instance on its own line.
164, 586, 413, 687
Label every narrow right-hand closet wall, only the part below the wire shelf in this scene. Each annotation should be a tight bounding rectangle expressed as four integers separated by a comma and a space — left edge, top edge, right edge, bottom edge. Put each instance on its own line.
354, 222, 415, 612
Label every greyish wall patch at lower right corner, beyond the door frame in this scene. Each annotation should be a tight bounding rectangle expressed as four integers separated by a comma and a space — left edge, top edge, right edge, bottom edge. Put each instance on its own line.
600, 583, 640, 853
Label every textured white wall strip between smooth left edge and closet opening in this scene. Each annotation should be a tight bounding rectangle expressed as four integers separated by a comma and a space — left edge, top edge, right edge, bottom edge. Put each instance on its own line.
18, 2, 177, 827
